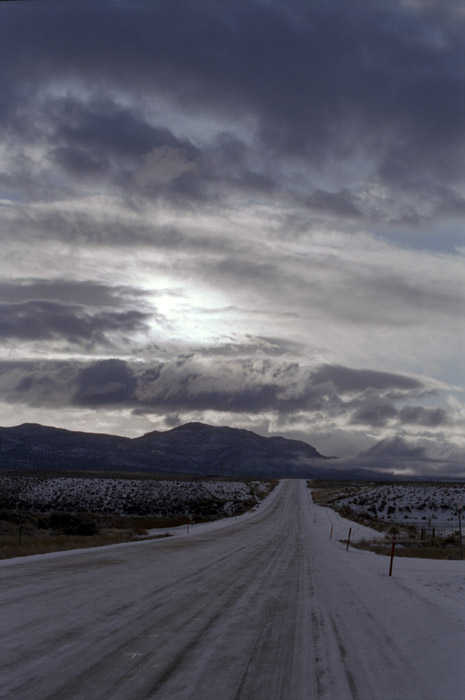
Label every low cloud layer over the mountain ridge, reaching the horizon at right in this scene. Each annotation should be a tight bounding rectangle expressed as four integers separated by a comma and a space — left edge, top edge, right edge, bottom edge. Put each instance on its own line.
0, 355, 463, 475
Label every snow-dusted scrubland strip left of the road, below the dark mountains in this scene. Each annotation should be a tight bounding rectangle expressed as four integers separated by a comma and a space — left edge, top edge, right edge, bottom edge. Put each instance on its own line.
0, 474, 269, 517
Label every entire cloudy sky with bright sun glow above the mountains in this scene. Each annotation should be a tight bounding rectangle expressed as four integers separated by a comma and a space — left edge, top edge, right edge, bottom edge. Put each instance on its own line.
0, 0, 465, 477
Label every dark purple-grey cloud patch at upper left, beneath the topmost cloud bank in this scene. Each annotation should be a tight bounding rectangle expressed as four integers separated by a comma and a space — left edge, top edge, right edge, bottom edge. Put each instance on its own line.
0, 86, 276, 204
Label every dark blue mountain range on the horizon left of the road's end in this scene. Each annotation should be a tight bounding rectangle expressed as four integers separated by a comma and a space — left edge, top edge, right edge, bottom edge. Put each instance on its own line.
0, 423, 356, 478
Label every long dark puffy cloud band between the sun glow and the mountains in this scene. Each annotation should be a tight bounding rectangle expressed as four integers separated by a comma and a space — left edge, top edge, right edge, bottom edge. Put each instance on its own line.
0, 355, 425, 422
